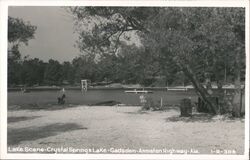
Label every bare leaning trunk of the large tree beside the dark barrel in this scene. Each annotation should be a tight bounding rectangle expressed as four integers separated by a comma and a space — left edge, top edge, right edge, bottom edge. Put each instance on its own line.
181, 65, 218, 114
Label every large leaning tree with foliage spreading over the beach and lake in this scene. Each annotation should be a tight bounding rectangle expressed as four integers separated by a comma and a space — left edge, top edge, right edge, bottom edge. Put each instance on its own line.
71, 7, 245, 114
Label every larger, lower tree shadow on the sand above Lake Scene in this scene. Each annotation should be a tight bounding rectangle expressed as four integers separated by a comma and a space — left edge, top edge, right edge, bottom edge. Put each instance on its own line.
7, 123, 87, 145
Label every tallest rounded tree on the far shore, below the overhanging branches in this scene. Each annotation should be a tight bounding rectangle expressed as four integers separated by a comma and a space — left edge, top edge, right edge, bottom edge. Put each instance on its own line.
117, 44, 160, 86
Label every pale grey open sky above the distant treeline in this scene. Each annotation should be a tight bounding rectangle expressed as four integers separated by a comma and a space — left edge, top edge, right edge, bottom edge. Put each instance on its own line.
9, 6, 80, 62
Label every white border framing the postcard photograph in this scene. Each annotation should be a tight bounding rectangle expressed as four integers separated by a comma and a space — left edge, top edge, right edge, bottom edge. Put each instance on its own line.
0, 0, 249, 160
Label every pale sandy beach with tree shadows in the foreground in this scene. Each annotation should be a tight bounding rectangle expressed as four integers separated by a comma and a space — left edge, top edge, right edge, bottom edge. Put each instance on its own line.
8, 106, 244, 154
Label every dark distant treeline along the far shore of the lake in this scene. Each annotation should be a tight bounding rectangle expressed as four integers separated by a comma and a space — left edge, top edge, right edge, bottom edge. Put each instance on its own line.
8, 43, 244, 87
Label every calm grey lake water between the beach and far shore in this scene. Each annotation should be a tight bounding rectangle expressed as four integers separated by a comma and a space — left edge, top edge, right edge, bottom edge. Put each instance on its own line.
8, 90, 197, 105
